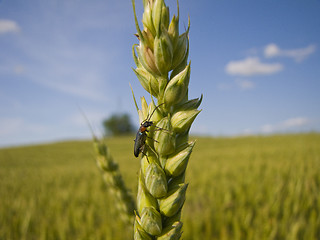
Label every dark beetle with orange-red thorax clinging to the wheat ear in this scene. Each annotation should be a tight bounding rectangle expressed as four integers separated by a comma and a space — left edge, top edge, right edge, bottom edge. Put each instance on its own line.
133, 103, 164, 157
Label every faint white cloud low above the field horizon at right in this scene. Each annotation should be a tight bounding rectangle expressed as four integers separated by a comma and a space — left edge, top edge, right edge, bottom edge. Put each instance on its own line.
261, 117, 310, 133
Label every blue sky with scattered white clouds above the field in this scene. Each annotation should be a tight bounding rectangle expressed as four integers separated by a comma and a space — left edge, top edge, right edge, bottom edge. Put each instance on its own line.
0, 0, 320, 146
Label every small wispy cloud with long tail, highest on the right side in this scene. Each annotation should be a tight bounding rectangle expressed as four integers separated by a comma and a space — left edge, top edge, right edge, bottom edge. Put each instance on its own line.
264, 43, 316, 62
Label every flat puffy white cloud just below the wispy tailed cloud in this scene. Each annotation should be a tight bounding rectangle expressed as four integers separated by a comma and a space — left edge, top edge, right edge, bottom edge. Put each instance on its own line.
225, 57, 283, 76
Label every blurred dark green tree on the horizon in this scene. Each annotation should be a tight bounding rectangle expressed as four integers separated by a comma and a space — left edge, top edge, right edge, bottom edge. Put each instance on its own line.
102, 113, 133, 136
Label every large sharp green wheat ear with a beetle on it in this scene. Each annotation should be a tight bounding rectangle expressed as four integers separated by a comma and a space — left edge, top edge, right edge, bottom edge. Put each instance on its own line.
132, 0, 202, 240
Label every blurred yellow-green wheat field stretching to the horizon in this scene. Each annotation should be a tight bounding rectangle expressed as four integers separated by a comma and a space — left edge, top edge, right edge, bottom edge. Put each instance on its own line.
0, 134, 320, 240
